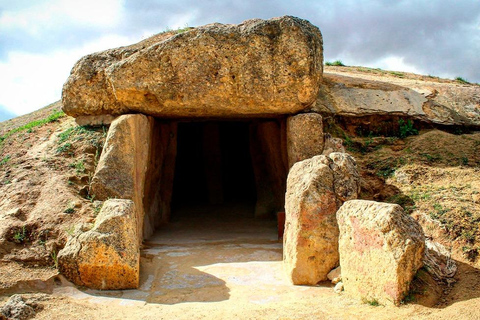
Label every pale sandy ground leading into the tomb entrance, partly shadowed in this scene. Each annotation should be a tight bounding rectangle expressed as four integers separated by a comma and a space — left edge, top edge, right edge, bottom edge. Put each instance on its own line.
1, 207, 474, 319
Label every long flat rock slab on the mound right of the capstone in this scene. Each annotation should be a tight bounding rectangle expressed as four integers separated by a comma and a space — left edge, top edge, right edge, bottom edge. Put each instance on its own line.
312, 72, 480, 126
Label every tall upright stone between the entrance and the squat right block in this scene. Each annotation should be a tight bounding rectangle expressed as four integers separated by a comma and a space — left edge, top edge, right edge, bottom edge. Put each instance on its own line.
283, 153, 360, 285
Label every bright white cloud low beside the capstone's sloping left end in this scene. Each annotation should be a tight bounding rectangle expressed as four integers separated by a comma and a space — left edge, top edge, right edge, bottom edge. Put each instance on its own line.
0, 35, 133, 115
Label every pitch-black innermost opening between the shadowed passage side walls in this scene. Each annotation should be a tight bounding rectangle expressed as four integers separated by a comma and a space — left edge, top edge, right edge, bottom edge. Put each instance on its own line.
172, 121, 256, 219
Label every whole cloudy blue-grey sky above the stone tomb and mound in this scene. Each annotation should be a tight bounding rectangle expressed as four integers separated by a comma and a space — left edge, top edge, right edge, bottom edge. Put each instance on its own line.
0, 0, 480, 121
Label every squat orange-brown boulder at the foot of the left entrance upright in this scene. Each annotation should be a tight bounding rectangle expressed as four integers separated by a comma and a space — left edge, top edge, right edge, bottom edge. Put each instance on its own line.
58, 199, 140, 289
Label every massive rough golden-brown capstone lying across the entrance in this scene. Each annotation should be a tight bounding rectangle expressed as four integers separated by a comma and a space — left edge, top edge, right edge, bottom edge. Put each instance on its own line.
62, 16, 323, 117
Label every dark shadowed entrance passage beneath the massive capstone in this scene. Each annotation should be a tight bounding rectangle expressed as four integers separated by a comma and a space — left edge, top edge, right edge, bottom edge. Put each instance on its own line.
143, 119, 288, 239
